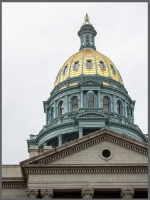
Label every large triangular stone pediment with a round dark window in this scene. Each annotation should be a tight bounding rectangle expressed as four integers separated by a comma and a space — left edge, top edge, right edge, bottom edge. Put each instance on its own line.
20, 129, 148, 167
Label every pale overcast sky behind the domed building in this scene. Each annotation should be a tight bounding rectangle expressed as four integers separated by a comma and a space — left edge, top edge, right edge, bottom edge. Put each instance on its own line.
2, 2, 148, 164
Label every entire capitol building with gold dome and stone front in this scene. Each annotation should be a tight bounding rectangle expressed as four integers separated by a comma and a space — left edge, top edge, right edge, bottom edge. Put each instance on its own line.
2, 14, 148, 199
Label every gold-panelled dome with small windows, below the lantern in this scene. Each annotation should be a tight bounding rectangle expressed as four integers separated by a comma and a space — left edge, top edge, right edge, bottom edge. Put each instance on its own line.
54, 49, 124, 86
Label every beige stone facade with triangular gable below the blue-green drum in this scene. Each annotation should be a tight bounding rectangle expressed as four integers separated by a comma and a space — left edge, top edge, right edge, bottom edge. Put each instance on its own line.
2, 129, 148, 198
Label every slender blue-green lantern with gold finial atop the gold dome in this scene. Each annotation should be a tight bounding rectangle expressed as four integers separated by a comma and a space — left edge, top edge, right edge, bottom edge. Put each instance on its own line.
78, 13, 97, 50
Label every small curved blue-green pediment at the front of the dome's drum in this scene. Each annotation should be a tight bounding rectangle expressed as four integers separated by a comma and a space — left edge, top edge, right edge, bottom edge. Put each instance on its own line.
76, 111, 108, 120
